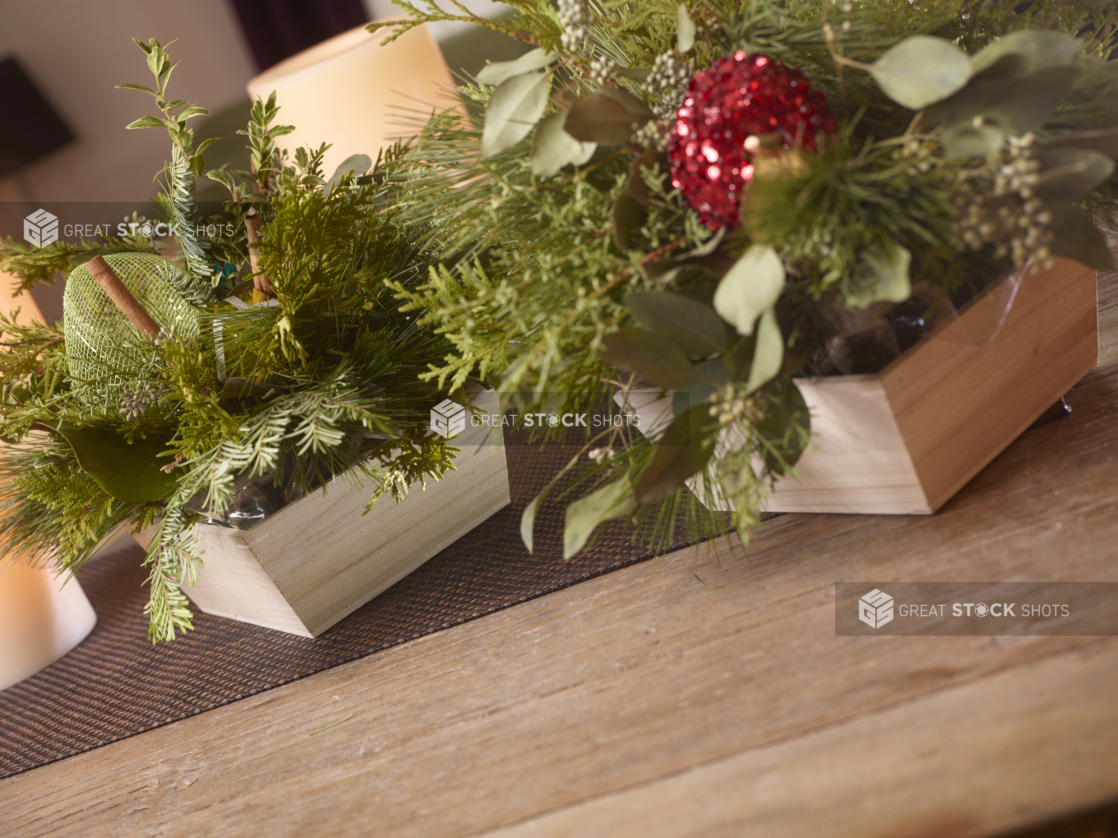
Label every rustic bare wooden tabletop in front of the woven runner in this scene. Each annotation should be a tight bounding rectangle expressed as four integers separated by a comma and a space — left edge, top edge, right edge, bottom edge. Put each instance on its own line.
0, 263, 1118, 838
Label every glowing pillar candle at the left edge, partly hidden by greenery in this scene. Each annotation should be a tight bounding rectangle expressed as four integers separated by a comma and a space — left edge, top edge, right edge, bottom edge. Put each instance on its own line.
0, 272, 97, 689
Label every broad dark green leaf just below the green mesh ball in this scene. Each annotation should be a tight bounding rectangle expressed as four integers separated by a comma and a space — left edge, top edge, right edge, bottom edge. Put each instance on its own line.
54, 422, 177, 503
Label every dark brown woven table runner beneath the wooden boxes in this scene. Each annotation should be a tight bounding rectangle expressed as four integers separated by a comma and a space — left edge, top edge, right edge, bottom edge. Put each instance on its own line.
0, 445, 702, 778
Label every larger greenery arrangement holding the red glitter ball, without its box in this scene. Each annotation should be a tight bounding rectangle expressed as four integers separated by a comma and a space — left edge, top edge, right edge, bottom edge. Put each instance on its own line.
369, 0, 1118, 556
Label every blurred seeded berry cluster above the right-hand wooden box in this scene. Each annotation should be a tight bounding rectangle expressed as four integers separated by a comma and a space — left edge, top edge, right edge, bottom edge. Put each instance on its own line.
954, 134, 1053, 270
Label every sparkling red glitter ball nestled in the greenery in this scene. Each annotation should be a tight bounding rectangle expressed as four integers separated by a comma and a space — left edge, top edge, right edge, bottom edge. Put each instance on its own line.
667, 51, 839, 230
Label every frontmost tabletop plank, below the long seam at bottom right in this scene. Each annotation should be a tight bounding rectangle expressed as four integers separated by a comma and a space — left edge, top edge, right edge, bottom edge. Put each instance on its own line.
485, 638, 1118, 838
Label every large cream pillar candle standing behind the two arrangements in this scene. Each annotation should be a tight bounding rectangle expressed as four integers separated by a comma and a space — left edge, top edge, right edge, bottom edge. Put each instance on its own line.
248, 26, 454, 178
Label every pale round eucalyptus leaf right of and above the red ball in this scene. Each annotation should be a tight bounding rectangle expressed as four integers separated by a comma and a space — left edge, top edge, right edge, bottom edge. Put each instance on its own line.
870, 35, 972, 111
